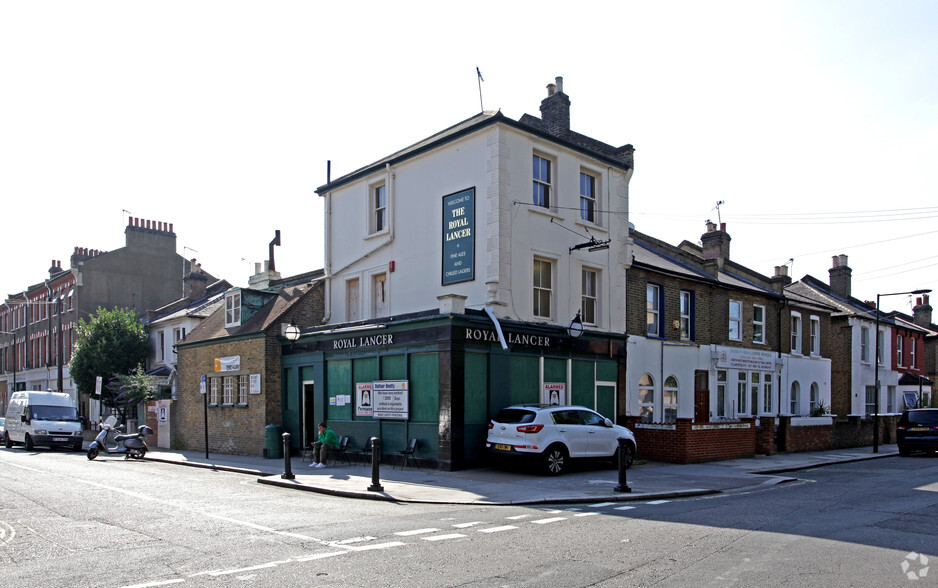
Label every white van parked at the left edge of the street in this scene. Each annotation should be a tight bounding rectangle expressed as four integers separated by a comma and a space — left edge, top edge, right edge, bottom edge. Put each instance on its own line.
3, 390, 82, 451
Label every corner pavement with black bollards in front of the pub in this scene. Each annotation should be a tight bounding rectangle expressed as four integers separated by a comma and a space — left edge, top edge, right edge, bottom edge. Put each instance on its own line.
139, 445, 899, 505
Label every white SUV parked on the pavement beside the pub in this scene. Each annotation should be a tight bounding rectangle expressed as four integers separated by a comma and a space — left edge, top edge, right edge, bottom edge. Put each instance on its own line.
485, 404, 636, 476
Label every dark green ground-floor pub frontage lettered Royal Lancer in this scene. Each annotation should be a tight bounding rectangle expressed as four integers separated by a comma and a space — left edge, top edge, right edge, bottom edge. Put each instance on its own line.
281, 310, 627, 470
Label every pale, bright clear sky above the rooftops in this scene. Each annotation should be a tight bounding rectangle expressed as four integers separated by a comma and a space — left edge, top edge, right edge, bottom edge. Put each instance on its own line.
0, 0, 938, 312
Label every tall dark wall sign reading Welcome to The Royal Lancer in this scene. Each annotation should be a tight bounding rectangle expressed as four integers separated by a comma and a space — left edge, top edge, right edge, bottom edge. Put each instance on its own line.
442, 188, 476, 286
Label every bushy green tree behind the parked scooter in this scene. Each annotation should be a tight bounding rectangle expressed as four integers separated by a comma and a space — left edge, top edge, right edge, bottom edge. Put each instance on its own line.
68, 307, 150, 414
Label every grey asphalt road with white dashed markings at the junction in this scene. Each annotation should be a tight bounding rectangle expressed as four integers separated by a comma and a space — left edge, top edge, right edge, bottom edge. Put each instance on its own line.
0, 449, 938, 588
